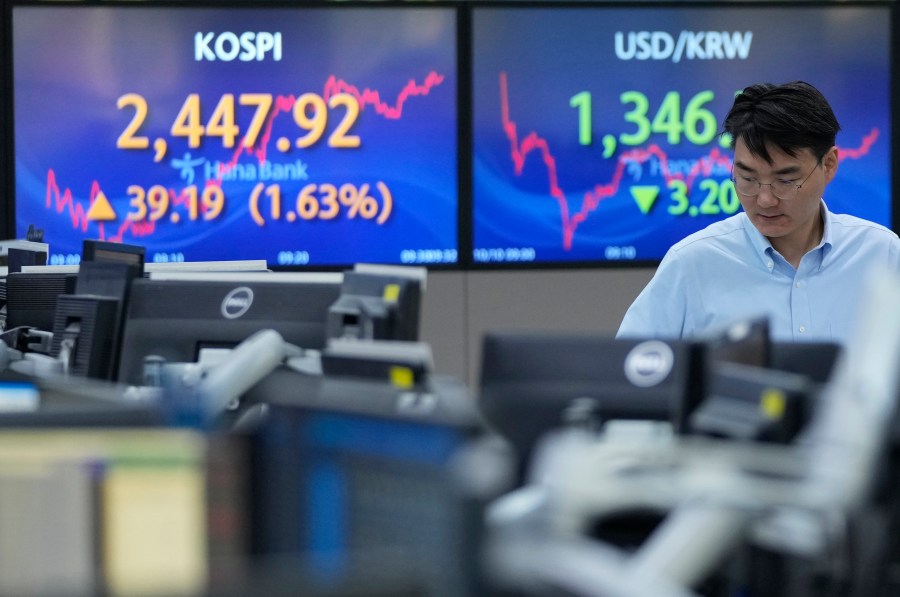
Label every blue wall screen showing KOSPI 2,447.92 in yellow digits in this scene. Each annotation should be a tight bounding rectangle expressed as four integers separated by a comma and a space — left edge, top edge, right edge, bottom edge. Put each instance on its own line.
12, 3, 458, 267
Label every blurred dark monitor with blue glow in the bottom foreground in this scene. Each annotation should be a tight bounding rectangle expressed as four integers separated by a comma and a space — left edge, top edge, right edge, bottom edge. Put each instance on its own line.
251, 371, 496, 597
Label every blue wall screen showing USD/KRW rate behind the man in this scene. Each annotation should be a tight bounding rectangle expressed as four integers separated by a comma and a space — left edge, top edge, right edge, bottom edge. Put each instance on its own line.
472, 3, 892, 265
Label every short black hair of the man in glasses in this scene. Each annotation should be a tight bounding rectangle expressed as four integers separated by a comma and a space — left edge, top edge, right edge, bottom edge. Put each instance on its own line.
724, 81, 841, 164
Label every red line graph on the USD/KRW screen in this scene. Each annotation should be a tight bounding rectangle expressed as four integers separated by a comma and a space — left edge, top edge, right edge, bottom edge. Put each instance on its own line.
500, 72, 879, 250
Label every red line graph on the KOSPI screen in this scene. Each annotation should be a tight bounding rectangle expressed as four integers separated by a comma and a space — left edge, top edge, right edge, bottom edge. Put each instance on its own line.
46, 71, 444, 242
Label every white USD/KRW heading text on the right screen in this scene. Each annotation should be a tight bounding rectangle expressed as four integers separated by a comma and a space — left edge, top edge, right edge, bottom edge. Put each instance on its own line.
615, 31, 753, 62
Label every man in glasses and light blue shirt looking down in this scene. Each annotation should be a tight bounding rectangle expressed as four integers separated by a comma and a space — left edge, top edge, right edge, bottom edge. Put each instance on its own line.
617, 81, 900, 342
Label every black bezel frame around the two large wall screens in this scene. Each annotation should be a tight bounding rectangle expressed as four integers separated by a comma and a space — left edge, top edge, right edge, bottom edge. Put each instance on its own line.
0, 0, 900, 271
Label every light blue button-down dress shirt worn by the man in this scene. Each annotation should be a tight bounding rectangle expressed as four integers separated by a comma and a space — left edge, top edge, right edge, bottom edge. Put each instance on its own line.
616, 201, 900, 343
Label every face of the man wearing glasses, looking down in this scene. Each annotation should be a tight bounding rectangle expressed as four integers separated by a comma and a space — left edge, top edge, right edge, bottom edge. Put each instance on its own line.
734, 139, 838, 240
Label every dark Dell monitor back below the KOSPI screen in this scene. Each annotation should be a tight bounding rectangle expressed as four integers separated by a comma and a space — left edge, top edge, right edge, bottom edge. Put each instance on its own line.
118, 272, 343, 384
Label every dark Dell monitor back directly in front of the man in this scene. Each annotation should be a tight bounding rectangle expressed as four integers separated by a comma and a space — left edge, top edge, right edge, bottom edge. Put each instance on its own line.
478, 332, 703, 474
